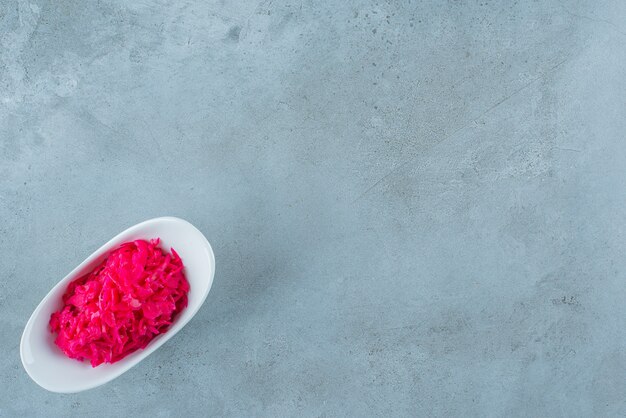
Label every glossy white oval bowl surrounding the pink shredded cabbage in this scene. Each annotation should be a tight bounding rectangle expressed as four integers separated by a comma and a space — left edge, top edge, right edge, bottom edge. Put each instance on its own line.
20, 217, 215, 393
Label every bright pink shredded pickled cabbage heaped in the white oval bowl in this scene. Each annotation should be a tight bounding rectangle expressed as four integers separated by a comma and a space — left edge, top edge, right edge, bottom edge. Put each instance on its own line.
50, 238, 189, 367
